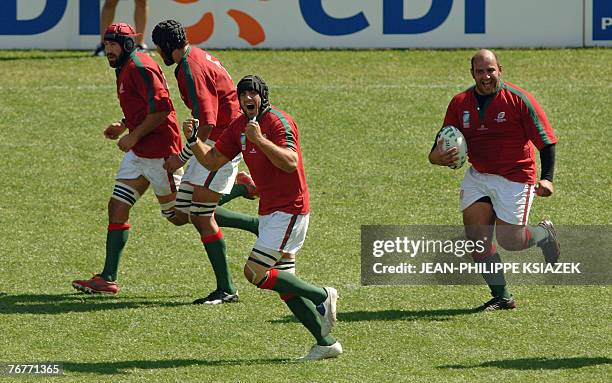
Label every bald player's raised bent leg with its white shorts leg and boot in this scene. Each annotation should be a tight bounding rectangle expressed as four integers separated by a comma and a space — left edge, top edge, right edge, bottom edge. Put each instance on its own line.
493, 177, 559, 263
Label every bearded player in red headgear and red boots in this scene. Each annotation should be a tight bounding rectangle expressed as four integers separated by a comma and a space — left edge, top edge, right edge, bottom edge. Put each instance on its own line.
72, 23, 182, 294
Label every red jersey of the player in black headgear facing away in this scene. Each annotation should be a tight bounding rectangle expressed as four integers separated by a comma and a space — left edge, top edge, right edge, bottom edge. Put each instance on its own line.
174, 46, 240, 141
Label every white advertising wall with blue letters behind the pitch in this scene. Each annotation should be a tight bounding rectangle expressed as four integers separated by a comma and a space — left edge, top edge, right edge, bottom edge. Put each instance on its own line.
0, 0, 612, 49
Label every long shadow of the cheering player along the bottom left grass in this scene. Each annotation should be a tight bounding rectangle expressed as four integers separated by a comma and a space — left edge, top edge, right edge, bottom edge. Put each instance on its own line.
59, 358, 294, 375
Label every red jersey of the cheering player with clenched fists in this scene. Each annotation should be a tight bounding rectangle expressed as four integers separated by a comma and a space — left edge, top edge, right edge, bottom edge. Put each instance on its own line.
215, 107, 310, 215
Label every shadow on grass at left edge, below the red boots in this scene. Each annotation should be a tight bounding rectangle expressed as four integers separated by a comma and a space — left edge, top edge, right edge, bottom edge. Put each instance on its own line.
0, 293, 191, 314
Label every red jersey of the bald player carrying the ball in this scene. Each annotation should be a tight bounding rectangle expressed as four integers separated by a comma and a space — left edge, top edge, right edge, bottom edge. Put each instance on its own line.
444, 81, 557, 184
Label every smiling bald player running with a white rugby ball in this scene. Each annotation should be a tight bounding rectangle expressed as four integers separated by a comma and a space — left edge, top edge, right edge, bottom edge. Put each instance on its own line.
429, 49, 560, 311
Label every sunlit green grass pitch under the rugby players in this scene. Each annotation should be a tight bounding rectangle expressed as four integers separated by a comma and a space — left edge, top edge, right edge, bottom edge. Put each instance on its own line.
0, 49, 612, 383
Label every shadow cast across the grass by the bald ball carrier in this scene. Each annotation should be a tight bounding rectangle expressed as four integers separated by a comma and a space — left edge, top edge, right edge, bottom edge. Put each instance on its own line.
271, 308, 480, 323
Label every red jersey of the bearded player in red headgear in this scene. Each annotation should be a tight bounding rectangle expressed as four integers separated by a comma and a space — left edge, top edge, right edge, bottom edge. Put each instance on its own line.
116, 52, 182, 158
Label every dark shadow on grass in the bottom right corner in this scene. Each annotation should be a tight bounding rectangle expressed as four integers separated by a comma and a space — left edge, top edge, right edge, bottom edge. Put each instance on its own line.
438, 357, 612, 370
